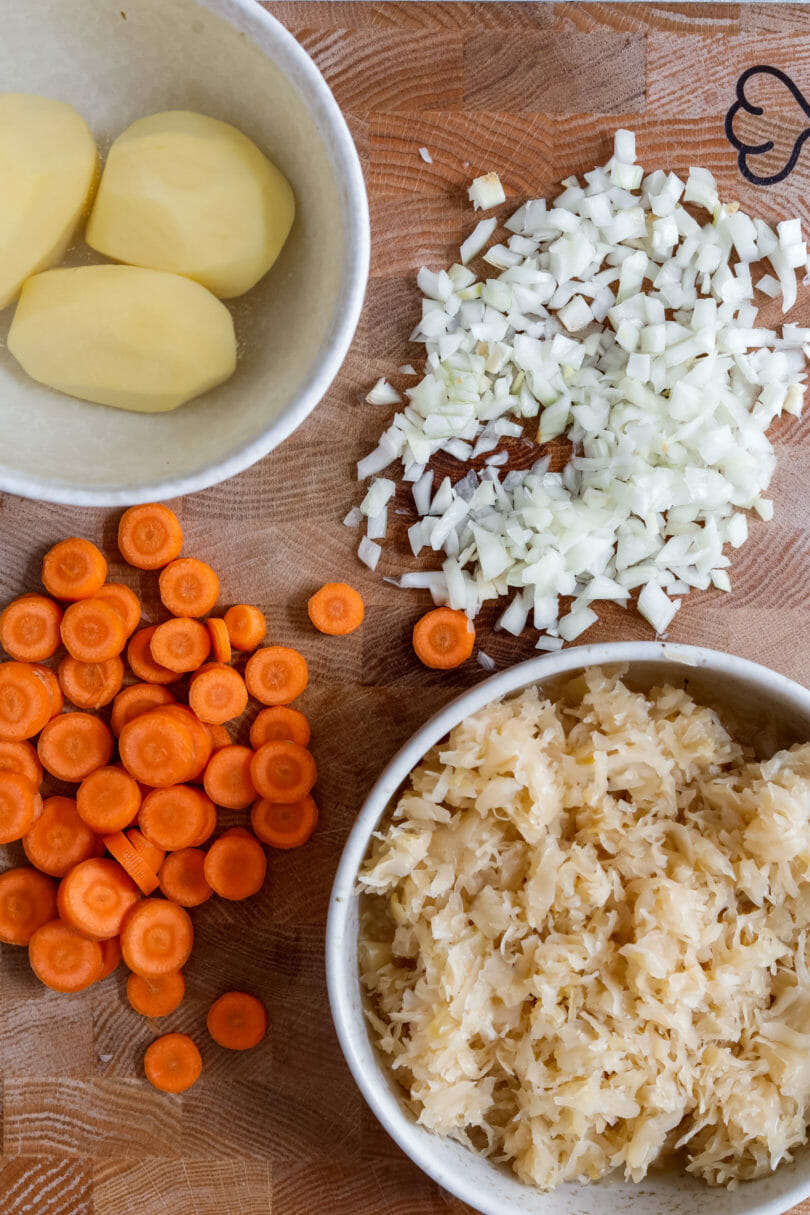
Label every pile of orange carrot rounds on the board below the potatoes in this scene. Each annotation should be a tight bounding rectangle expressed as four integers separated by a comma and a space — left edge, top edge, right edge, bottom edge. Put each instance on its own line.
0, 503, 323, 1092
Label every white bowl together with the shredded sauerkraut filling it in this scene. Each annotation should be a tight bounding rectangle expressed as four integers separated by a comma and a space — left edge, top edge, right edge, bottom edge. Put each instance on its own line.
327, 643, 810, 1215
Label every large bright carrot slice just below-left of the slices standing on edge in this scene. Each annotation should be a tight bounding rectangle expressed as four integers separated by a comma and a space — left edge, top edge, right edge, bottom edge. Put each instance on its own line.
56, 857, 141, 940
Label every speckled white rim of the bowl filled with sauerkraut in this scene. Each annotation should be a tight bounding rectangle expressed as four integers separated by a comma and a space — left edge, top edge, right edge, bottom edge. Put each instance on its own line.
325, 642, 810, 1215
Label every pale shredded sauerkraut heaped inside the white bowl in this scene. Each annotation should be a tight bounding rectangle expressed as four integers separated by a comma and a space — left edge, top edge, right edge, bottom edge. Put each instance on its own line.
359, 669, 810, 1188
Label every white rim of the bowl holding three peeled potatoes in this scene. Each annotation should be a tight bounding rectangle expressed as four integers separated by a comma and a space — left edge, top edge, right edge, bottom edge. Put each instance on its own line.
0, 0, 372, 507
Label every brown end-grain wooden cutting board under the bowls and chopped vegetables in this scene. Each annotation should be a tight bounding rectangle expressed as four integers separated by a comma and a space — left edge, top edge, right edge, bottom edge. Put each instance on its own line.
0, 0, 810, 1215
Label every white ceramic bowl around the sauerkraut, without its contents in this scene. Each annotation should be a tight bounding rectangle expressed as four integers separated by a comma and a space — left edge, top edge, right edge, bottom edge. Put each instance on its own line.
327, 642, 810, 1215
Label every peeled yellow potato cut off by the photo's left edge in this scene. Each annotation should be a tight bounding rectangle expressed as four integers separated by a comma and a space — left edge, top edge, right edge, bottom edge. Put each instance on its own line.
0, 92, 98, 307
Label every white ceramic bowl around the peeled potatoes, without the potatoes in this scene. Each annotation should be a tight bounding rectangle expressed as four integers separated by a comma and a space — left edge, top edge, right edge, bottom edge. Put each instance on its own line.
0, 0, 369, 505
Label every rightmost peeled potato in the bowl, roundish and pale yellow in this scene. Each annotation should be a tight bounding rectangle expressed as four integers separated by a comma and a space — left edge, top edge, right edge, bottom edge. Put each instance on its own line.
87, 109, 295, 299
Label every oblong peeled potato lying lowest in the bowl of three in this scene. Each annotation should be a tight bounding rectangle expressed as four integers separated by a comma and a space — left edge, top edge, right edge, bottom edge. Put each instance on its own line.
9, 266, 237, 413
